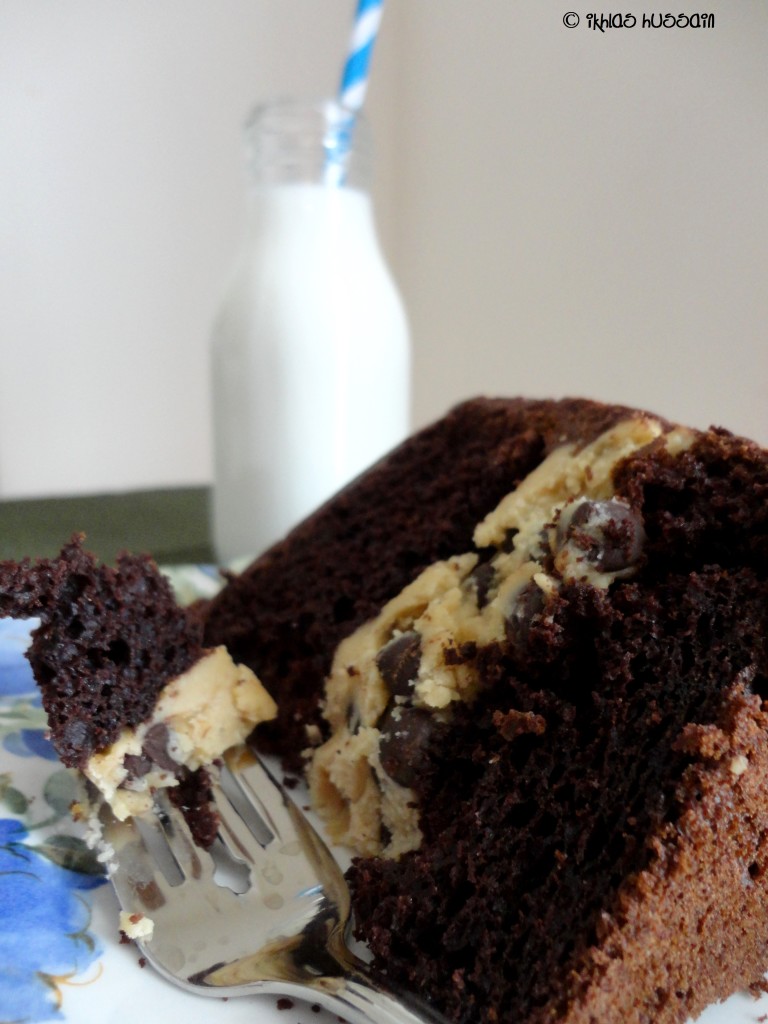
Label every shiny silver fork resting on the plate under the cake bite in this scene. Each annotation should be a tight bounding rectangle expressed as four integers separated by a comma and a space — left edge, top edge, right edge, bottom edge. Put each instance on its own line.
94, 748, 444, 1024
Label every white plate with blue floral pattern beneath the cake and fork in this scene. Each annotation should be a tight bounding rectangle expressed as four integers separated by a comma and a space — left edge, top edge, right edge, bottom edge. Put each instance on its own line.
0, 566, 768, 1024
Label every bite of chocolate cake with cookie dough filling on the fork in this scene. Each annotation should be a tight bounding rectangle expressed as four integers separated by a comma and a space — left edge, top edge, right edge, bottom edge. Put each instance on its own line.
0, 538, 274, 845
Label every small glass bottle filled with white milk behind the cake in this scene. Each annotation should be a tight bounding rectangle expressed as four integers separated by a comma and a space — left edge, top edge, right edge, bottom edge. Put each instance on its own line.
212, 100, 410, 562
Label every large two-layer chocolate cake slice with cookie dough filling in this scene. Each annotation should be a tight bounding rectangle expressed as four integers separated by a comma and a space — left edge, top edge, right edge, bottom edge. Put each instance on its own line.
206, 399, 768, 1024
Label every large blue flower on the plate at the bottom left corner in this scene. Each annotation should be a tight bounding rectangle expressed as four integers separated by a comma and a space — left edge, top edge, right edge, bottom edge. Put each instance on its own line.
0, 818, 103, 1024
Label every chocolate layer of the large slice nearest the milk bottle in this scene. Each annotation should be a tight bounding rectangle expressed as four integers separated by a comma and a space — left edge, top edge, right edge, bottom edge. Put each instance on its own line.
205, 398, 643, 769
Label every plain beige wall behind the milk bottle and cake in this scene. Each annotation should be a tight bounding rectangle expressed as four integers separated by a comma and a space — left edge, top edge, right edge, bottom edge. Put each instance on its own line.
0, 0, 768, 499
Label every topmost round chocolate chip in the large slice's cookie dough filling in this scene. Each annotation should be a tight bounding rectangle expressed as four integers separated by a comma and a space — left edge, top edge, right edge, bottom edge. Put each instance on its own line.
557, 500, 645, 572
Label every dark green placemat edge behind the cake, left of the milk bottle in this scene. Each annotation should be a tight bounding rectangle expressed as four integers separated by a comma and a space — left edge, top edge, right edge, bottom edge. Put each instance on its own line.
0, 487, 213, 564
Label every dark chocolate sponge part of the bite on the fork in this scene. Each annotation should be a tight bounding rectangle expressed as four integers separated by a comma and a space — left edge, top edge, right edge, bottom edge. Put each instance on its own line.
0, 537, 202, 768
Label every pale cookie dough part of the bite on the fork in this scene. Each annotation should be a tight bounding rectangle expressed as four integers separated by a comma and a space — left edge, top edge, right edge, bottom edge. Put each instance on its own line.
83, 647, 276, 821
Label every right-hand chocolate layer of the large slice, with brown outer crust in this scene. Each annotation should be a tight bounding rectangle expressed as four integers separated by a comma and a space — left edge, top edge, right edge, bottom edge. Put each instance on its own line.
342, 432, 768, 1024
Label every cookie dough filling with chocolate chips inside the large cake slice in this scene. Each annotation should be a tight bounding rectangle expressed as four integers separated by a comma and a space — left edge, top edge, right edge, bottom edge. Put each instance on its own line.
309, 416, 694, 857
